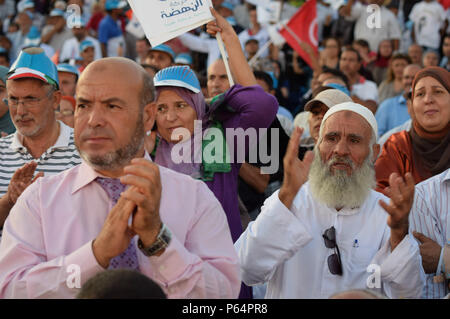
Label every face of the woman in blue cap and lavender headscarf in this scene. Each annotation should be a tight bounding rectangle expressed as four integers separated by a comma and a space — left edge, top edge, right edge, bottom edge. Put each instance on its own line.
156, 90, 197, 143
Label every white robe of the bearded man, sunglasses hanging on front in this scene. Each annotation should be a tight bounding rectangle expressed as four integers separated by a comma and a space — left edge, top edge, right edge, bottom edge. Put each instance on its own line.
235, 183, 425, 298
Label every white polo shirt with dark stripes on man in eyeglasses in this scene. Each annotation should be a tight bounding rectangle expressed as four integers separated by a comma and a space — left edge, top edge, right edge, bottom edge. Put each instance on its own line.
0, 121, 81, 196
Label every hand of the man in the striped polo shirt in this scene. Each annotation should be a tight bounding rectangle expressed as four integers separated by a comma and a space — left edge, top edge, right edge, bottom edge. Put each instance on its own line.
5, 162, 44, 207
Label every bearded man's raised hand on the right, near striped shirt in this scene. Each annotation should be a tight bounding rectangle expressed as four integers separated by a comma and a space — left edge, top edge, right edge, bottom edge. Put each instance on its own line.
379, 173, 414, 251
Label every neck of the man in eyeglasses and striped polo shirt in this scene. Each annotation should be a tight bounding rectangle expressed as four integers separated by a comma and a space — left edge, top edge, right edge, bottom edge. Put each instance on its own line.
23, 119, 60, 159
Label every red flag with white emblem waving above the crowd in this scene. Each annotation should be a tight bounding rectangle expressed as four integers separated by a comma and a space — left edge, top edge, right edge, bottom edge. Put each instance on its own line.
280, 0, 318, 67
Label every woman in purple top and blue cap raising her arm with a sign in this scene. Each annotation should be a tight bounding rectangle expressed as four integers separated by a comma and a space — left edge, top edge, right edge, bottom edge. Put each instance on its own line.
147, 11, 278, 242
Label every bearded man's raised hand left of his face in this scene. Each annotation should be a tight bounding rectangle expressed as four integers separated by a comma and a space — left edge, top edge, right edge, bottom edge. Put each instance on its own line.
278, 127, 314, 208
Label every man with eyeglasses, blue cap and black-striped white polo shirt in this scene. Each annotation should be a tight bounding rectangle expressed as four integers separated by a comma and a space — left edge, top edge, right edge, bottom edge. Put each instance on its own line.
0, 48, 81, 231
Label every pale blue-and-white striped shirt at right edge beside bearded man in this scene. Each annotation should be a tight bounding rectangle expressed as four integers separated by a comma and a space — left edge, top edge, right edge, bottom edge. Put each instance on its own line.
409, 168, 450, 299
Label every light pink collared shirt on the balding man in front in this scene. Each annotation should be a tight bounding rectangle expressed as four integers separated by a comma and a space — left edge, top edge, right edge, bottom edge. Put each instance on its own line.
0, 156, 241, 298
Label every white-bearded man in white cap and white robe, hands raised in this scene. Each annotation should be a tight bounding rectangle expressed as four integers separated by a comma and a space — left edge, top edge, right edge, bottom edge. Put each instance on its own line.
235, 102, 425, 298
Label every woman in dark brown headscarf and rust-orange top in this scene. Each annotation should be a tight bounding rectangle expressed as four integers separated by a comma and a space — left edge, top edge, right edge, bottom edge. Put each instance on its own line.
375, 67, 450, 191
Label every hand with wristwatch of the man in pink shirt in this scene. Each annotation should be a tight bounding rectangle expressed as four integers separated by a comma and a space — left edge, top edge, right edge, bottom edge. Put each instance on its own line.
120, 158, 162, 253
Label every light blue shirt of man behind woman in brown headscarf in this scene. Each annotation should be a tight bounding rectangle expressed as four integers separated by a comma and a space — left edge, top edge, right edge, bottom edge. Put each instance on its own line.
375, 94, 411, 136
